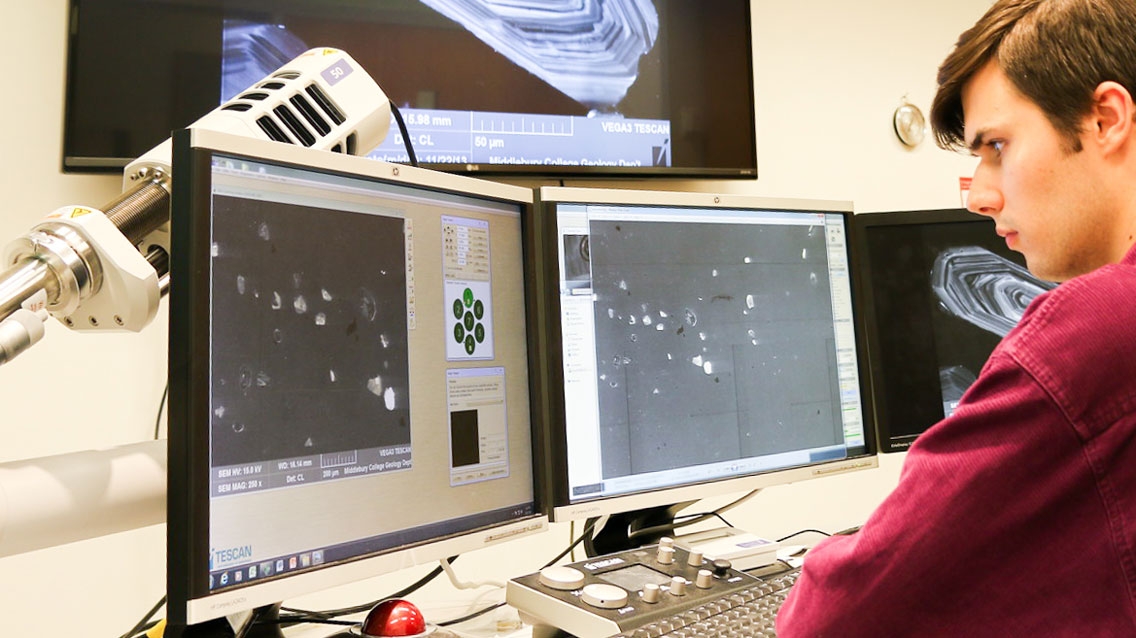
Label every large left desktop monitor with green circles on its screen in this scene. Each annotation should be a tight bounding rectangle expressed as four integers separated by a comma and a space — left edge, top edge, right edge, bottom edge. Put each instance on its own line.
167, 125, 548, 636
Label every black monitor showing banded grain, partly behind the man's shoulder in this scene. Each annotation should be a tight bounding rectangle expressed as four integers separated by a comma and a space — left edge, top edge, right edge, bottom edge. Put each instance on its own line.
853, 209, 1054, 452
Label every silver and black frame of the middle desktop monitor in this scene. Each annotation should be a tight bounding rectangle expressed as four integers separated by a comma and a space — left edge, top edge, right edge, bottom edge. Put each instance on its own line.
533, 186, 879, 522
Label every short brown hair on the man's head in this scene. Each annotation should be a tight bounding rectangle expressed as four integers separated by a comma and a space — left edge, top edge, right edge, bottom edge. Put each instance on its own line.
930, 0, 1136, 151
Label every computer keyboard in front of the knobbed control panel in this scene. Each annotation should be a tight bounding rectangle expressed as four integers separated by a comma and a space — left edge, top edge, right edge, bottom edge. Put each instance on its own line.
617, 568, 801, 638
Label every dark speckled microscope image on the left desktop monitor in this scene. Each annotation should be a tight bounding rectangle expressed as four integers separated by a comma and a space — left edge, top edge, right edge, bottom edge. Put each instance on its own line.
211, 195, 410, 467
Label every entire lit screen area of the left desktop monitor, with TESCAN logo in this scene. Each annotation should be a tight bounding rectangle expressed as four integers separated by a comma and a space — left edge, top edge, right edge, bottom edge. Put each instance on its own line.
201, 156, 535, 589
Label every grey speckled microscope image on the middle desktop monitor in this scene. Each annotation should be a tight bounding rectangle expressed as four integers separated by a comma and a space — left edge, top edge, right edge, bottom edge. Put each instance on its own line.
586, 221, 843, 478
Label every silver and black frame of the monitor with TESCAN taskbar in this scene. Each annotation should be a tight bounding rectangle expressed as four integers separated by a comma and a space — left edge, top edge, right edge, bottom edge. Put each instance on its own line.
167, 129, 548, 627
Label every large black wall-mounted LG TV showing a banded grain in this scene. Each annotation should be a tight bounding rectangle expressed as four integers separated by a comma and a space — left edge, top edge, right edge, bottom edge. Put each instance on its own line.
62, 0, 757, 177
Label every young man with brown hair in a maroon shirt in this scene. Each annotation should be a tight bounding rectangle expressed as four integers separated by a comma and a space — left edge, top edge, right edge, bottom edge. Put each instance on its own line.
778, 0, 1136, 638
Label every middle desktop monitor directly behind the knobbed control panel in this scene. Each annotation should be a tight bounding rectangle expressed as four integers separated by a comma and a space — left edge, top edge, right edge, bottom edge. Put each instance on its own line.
524, 187, 877, 551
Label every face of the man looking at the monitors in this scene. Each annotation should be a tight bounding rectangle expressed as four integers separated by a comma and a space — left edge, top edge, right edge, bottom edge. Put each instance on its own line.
962, 61, 1118, 282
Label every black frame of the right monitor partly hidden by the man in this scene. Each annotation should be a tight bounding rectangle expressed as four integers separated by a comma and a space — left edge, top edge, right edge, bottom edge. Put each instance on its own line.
852, 208, 994, 454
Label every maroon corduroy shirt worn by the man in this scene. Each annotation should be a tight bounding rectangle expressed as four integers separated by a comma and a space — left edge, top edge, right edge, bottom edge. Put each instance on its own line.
777, 241, 1136, 638
